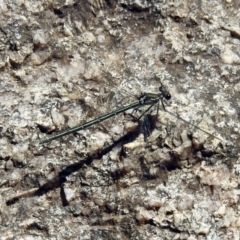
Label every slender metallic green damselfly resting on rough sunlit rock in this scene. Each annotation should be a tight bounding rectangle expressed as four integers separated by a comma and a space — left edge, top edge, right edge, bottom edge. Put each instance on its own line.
39, 85, 171, 144
